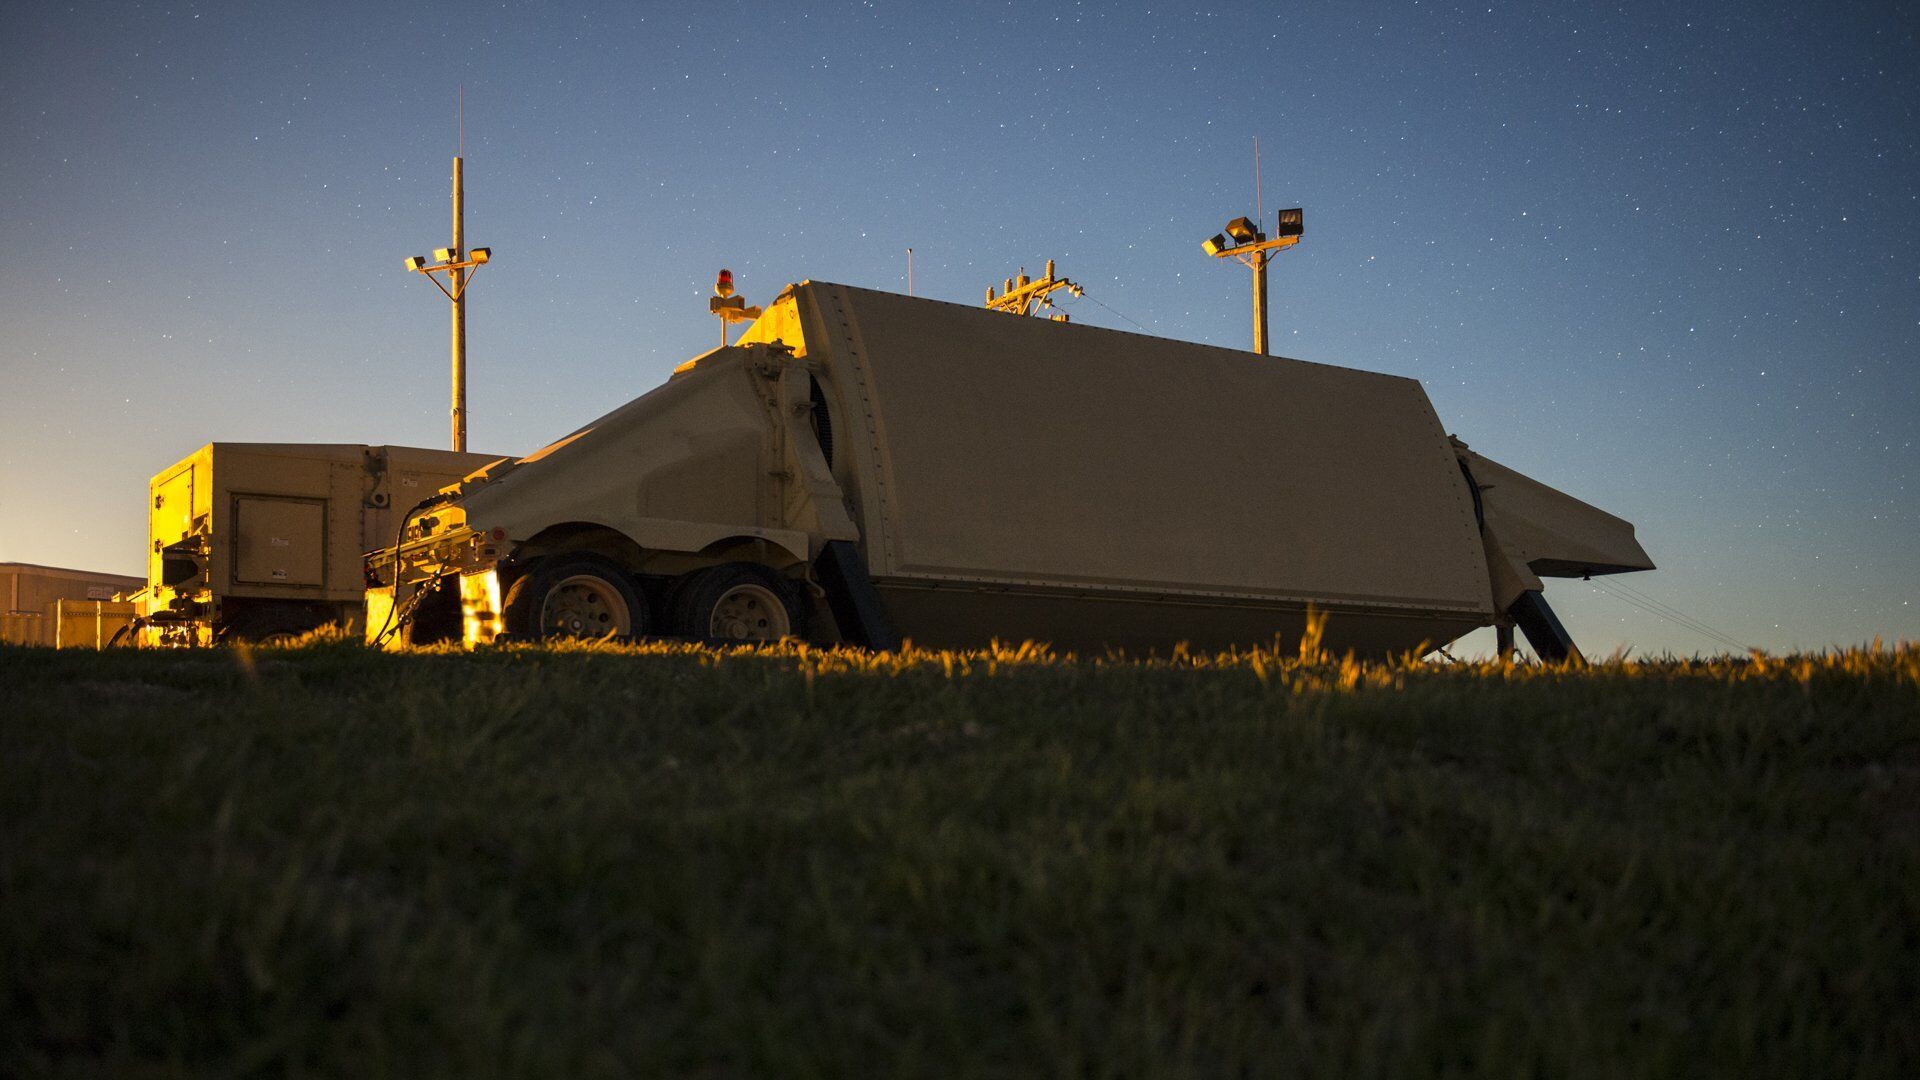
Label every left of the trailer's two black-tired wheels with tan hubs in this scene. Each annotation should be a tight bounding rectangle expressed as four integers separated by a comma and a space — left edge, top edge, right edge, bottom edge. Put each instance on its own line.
501, 552, 651, 642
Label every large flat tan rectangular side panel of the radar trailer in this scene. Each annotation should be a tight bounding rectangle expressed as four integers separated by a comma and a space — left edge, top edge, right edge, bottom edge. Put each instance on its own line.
801, 282, 1490, 613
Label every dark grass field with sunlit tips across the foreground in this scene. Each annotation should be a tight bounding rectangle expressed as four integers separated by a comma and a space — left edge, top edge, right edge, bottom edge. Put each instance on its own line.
0, 642, 1920, 1076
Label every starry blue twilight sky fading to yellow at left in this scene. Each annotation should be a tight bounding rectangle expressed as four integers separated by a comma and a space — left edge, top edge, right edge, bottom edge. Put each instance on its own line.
0, 2, 1920, 653
